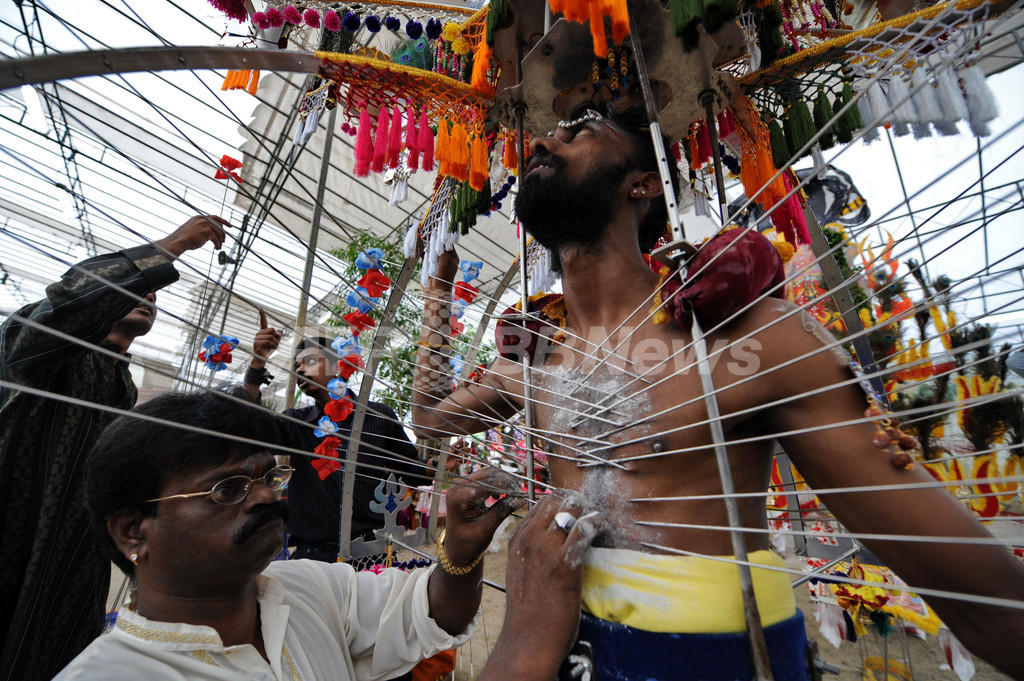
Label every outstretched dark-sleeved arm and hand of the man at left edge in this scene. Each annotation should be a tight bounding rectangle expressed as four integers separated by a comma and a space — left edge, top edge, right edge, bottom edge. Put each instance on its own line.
0, 215, 227, 378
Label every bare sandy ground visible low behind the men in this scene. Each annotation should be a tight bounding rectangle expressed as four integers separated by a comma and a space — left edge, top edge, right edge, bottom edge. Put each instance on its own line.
108, 538, 1010, 681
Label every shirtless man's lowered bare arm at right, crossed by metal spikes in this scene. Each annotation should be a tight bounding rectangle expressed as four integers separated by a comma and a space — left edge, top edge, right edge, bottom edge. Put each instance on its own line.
765, 307, 1024, 678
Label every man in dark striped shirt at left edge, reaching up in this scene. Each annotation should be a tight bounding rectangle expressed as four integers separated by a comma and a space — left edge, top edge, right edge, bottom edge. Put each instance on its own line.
0, 215, 227, 681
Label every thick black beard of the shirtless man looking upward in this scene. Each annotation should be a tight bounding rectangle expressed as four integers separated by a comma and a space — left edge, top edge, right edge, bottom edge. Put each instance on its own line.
515, 155, 629, 255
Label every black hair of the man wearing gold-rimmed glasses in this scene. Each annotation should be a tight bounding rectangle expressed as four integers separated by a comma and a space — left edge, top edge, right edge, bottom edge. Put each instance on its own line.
85, 391, 282, 576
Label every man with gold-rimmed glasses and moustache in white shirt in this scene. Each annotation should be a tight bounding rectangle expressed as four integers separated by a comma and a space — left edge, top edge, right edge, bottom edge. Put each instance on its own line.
56, 392, 597, 681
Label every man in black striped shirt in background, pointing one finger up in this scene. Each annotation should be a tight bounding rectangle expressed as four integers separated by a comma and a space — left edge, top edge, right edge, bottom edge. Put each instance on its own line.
245, 325, 431, 562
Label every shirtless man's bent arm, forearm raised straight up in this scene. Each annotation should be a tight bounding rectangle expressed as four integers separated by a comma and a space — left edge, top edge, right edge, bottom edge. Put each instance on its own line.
412, 246, 518, 437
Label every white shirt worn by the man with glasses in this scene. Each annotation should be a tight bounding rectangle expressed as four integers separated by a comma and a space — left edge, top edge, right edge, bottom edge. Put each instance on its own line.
55, 560, 479, 681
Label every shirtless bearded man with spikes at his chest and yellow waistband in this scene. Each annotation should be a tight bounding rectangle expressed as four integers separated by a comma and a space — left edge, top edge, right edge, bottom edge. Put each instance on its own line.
413, 103, 1024, 680
